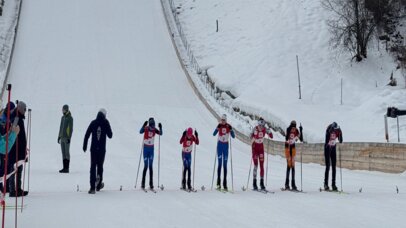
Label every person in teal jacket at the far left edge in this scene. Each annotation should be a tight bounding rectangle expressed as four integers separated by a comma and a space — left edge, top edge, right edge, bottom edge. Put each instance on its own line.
0, 102, 20, 192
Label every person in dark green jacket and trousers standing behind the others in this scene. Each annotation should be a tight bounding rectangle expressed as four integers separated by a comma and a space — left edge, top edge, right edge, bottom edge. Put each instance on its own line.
58, 104, 73, 173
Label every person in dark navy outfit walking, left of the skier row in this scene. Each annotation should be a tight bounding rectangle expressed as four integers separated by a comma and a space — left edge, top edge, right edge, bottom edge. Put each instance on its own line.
83, 108, 113, 194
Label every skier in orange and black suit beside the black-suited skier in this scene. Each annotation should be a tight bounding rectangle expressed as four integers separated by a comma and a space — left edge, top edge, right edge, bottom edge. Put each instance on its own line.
285, 120, 303, 191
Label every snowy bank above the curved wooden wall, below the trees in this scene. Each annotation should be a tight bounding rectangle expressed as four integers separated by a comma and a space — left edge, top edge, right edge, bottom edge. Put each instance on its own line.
174, 0, 406, 142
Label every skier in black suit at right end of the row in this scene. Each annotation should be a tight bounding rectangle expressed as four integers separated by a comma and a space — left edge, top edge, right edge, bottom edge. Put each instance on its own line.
324, 122, 343, 191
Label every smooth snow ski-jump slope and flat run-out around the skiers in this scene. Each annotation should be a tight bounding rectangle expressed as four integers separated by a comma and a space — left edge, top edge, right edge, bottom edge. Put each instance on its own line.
0, 0, 406, 228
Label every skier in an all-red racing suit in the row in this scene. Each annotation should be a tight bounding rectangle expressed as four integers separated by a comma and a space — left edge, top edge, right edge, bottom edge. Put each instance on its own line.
251, 117, 273, 190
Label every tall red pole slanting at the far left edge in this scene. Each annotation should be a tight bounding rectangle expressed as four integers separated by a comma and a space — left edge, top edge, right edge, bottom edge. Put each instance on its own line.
1, 84, 11, 228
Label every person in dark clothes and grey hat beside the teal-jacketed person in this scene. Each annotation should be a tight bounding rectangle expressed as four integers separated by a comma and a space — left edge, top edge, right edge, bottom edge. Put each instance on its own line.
7, 101, 28, 197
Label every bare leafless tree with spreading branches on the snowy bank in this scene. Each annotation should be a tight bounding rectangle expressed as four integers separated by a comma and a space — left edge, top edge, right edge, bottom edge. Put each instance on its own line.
322, 0, 376, 62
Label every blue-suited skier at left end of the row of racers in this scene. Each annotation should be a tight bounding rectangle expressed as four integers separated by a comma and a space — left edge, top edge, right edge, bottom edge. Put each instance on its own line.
140, 117, 162, 189
